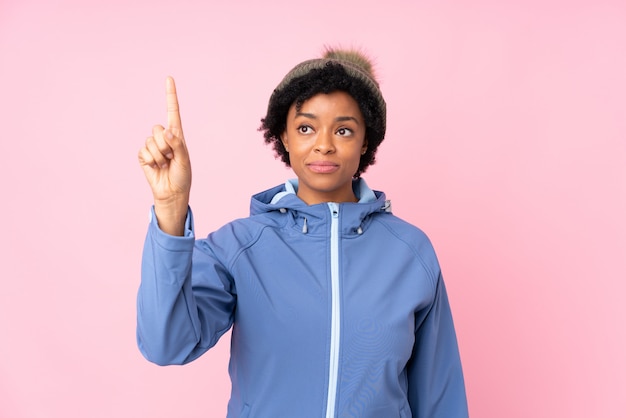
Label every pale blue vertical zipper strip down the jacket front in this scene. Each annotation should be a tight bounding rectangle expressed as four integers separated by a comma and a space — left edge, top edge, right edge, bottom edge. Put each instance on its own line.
326, 202, 341, 418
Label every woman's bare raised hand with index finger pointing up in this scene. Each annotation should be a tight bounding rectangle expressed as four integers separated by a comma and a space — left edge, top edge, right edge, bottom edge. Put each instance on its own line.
139, 77, 191, 235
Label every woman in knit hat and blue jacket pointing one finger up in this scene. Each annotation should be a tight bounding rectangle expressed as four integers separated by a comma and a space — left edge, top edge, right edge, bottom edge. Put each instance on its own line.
137, 50, 467, 418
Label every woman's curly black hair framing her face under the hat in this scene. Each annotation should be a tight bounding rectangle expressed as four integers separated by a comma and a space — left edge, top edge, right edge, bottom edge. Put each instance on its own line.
259, 61, 386, 178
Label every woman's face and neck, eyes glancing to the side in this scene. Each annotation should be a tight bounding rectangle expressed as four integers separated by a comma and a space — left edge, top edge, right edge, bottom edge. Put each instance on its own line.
281, 91, 367, 205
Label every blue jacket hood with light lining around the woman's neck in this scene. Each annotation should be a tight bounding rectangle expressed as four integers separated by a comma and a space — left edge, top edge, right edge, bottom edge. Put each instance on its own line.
250, 179, 391, 235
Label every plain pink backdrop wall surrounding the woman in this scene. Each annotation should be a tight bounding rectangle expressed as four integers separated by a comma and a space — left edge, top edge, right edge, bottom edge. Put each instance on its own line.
0, 0, 626, 418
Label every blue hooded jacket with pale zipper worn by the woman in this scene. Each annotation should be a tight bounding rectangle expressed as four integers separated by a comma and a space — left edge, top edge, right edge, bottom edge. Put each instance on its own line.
137, 180, 468, 418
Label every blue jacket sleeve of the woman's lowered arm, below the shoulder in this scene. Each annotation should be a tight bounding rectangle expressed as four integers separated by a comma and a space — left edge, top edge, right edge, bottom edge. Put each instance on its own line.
407, 274, 468, 418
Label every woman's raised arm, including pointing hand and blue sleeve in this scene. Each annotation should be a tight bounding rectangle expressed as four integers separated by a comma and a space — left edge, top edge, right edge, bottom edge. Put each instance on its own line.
137, 77, 235, 365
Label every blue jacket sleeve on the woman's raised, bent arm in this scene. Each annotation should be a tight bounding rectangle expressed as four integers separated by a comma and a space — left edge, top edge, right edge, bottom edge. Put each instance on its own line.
137, 208, 236, 365
